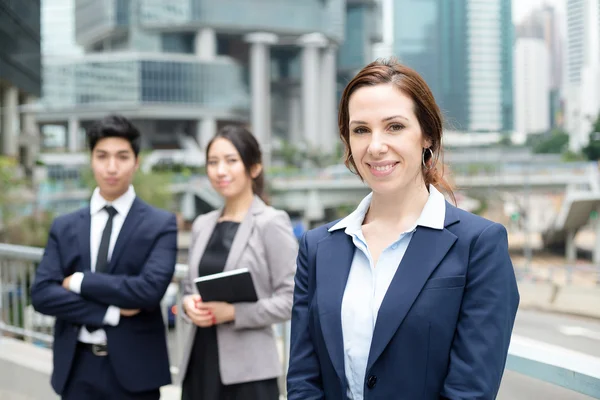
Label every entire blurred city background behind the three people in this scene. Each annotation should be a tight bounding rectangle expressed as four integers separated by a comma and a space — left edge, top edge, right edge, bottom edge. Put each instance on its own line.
0, 0, 600, 400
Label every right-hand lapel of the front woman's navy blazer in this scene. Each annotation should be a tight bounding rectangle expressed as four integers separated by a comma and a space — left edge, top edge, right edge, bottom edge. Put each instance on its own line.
367, 206, 458, 370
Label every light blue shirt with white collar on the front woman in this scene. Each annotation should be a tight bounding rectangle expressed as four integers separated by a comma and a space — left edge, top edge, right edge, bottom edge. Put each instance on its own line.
329, 185, 446, 400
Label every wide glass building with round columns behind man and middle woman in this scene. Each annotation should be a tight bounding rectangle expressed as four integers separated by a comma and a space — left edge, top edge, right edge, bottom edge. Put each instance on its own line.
37, 0, 380, 164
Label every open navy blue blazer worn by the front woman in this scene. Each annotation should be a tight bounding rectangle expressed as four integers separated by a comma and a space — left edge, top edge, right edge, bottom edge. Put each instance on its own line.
287, 203, 519, 400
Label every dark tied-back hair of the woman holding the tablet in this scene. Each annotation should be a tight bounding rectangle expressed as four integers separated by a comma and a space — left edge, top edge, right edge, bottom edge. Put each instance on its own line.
206, 125, 268, 203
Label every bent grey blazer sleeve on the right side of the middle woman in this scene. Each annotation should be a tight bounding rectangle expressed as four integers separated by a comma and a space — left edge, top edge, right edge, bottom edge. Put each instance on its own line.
234, 211, 298, 329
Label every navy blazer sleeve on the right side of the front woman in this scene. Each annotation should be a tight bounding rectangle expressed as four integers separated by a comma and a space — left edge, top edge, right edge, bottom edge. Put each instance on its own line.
440, 224, 519, 400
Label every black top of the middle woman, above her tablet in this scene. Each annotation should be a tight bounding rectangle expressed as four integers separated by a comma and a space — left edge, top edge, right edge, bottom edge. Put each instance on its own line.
198, 221, 240, 276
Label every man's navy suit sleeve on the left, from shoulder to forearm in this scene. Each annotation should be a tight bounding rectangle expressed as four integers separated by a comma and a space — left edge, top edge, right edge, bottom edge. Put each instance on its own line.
31, 221, 108, 326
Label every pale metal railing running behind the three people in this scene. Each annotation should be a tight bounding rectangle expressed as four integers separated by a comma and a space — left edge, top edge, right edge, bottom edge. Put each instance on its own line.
0, 244, 600, 398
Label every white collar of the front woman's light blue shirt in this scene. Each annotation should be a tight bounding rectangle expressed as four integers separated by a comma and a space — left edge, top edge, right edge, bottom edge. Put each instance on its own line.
329, 185, 446, 235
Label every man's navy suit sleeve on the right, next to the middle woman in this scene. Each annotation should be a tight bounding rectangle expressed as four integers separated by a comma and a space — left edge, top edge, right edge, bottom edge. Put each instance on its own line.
81, 215, 177, 309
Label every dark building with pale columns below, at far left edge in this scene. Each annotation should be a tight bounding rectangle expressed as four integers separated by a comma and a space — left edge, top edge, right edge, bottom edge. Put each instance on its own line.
0, 0, 41, 165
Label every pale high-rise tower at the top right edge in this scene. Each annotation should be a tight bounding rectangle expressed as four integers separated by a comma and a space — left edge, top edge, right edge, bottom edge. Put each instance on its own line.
565, 0, 600, 151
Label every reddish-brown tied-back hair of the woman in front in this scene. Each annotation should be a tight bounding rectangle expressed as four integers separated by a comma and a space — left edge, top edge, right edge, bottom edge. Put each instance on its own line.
338, 59, 456, 204
